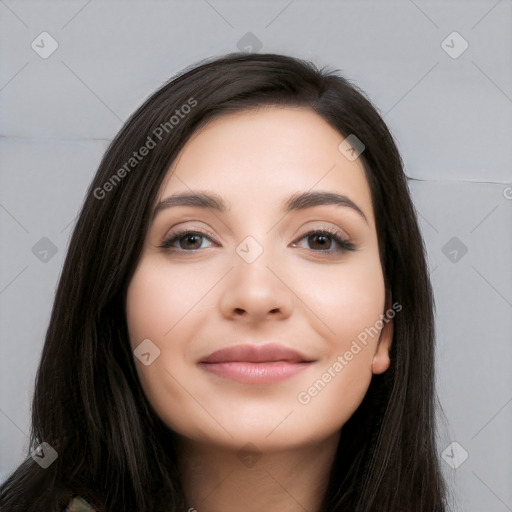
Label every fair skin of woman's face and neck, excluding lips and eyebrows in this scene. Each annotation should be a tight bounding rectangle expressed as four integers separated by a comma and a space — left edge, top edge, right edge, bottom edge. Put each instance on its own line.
126, 107, 392, 512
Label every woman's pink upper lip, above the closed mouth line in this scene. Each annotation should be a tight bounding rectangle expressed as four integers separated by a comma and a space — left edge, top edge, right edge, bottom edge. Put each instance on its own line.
200, 343, 313, 363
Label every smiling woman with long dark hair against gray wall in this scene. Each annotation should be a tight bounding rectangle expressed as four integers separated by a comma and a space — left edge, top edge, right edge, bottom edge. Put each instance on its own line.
0, 53, 445, 512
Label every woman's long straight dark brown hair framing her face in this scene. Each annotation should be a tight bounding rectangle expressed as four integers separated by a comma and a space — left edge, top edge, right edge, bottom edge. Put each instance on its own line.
0, 53, 446, 512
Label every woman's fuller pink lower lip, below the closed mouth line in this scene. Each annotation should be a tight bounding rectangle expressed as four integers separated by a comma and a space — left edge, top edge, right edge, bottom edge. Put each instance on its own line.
199, 361, 311, 384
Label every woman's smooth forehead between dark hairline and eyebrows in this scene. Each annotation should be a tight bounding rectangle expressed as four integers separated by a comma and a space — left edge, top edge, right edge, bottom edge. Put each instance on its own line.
159, 107, 373, 226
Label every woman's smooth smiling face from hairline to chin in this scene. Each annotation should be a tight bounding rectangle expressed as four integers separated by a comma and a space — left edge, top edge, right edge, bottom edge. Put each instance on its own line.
126, 107, 392, 451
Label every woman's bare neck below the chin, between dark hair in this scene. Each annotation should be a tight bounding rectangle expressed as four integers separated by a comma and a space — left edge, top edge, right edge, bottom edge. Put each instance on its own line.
173, 432, 339, 512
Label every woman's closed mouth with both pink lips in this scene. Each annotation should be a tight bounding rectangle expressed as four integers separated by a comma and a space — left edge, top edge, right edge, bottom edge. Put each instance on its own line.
198, 343, 315, 384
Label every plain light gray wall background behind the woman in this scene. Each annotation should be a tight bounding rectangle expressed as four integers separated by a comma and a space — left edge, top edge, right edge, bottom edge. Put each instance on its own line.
0, 0, 512, 512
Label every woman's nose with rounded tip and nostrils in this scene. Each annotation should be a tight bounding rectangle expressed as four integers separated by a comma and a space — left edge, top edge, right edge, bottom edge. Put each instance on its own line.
220, 245, 295, 323
